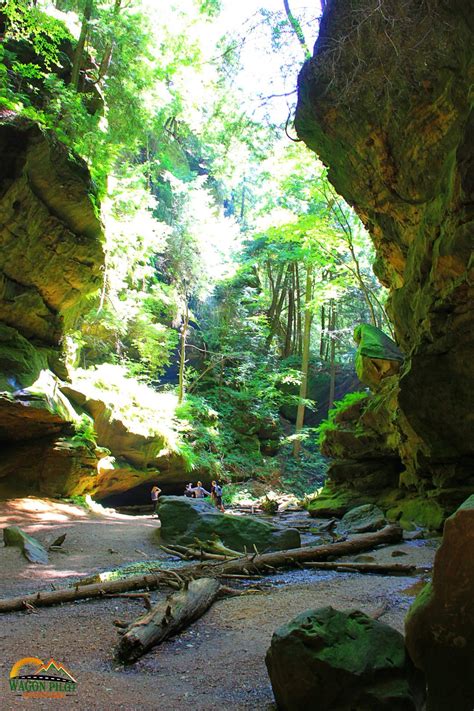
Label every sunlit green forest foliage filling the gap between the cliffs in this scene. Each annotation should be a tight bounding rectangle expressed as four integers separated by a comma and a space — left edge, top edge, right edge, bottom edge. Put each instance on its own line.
0, 0, 383, 496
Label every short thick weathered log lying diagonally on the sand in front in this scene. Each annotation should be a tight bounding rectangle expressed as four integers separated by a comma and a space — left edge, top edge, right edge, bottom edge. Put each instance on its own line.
115, 578, 220, 663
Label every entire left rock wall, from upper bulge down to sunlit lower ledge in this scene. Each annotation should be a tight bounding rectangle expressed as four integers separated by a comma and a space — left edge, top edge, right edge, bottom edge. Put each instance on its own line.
0, 116, 191, 496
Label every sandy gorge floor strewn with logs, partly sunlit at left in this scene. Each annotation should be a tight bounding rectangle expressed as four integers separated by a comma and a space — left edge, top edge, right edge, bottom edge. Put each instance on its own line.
0, 497, 437, 711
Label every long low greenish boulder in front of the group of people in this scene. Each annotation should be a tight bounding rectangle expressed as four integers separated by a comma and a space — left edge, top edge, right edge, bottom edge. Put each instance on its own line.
158, 496, 301, 553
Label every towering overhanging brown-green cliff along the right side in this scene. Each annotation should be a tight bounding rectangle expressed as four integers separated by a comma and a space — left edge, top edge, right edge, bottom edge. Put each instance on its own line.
295, 0, 474, 512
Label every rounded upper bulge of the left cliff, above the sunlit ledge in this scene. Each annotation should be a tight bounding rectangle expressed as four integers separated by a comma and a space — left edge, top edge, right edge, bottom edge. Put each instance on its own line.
0, 119, 104, 346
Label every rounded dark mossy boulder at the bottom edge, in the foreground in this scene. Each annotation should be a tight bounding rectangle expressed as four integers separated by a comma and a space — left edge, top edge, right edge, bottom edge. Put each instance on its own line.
265, 607, 424, 711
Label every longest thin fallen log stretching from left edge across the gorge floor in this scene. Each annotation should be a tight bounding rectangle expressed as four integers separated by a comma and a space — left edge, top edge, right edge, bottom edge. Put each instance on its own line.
0, 525, 402, 613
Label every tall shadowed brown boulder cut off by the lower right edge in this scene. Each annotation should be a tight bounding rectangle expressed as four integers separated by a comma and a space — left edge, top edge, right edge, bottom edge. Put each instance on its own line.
405, 495, 474, 711
